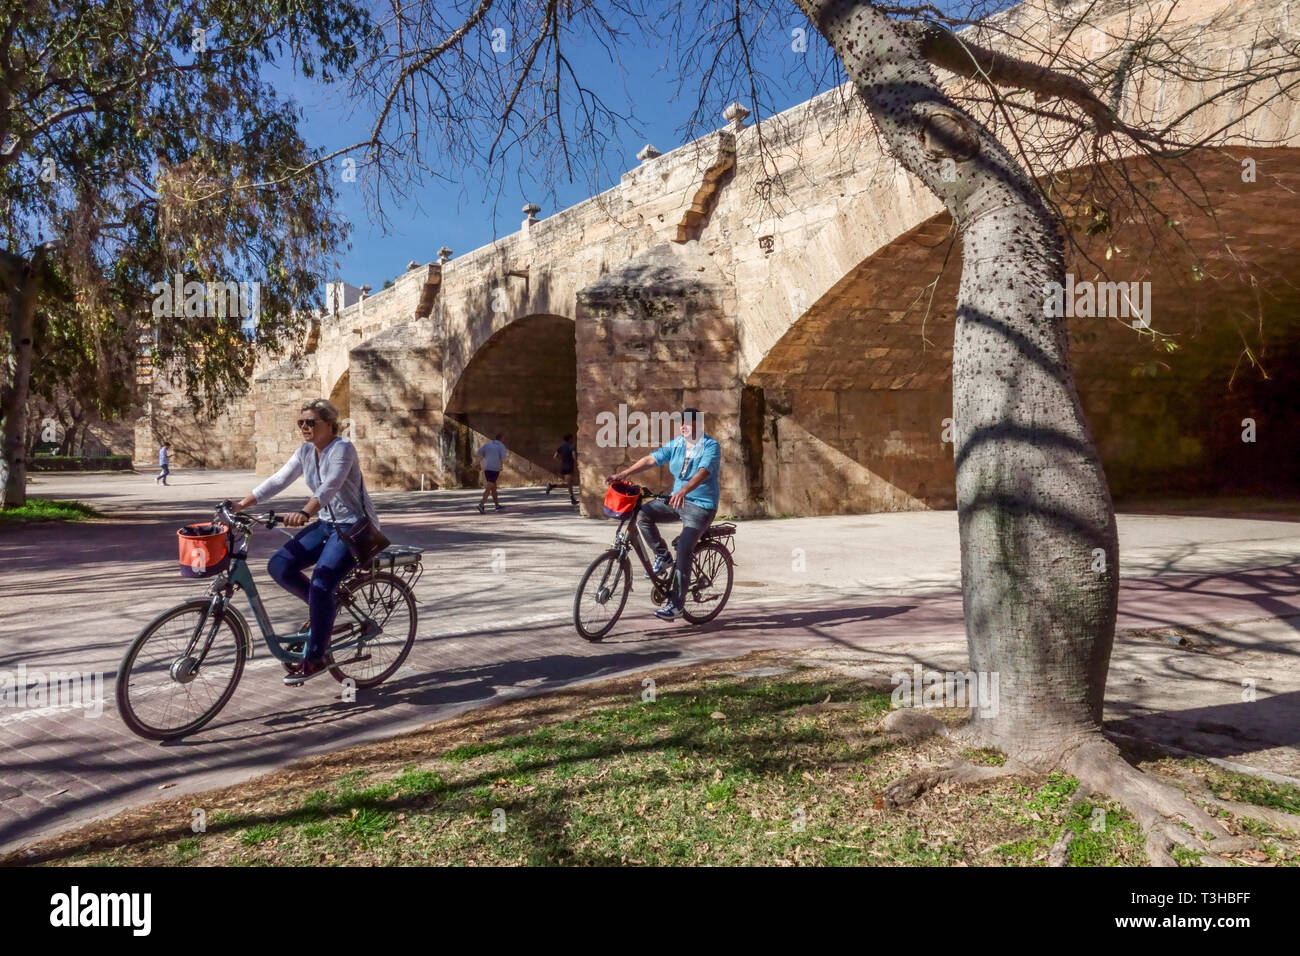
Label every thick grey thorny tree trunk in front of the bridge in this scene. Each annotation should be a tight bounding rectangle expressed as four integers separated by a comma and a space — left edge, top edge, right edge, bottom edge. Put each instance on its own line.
796, 0, 1118, 767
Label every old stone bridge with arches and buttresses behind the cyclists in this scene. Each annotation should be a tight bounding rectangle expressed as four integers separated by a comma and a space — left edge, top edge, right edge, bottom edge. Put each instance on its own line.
147, 0, 1300, 515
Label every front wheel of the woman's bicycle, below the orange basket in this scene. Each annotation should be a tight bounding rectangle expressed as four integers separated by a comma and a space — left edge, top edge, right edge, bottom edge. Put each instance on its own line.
116, 597, 248, 740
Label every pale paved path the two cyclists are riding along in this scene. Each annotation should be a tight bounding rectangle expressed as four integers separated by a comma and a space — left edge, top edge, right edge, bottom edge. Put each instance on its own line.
0, 471, 1300, 849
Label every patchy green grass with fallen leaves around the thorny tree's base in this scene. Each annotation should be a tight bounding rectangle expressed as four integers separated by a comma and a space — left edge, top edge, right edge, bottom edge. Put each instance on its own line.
30, 672, 1300, 866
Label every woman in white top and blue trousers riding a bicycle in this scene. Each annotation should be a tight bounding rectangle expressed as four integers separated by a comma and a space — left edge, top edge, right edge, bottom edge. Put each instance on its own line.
238, 398, 380, 685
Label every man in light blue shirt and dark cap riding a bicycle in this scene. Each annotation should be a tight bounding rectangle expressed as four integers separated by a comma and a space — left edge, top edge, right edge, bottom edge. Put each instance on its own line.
606, 408, 722, 620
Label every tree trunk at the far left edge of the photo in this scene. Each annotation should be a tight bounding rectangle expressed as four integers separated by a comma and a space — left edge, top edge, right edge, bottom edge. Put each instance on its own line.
0, 252, 46, 509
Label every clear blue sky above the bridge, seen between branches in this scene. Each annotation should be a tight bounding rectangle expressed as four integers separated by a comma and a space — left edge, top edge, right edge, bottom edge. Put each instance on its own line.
270, 10, 842, 290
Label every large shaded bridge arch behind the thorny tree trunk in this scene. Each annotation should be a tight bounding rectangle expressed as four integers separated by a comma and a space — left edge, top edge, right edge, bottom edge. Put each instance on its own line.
741, 147, 1300, 514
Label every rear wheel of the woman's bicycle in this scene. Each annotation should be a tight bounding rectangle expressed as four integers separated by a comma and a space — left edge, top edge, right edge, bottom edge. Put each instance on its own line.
329, 571, 417, 687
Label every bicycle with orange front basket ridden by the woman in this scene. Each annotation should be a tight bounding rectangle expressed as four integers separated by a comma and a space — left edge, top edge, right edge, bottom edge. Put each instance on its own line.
117, 503, 424, 740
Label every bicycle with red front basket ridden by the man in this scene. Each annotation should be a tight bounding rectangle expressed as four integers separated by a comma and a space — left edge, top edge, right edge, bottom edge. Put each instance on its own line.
573, 485, 736, 641
